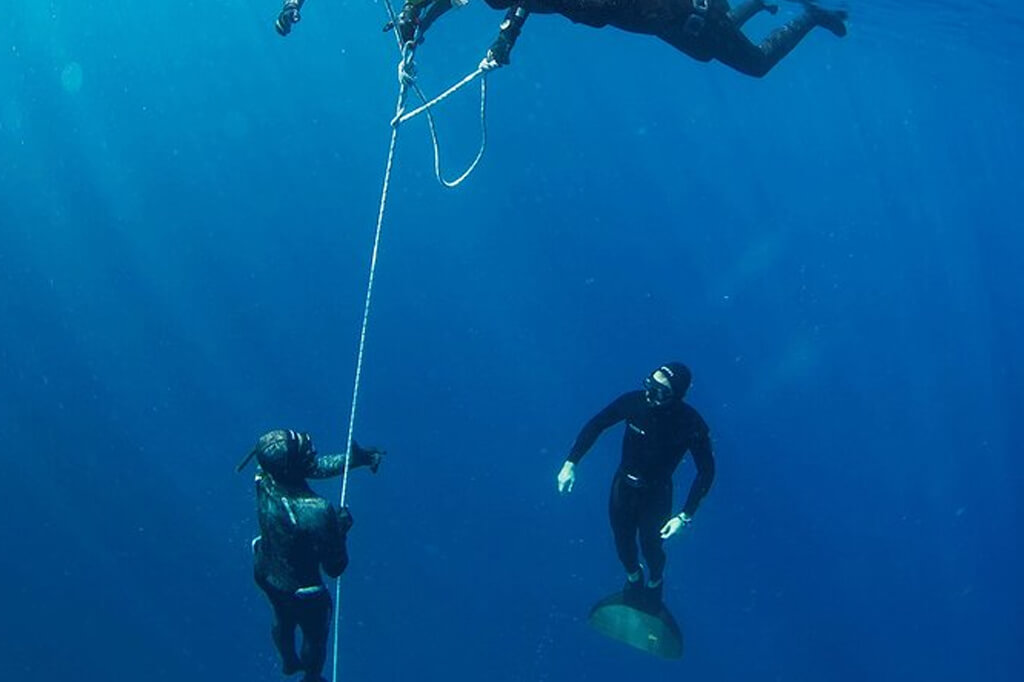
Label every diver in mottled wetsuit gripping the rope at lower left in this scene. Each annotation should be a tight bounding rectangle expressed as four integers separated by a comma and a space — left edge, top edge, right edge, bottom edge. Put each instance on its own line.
239, 430, 383, 682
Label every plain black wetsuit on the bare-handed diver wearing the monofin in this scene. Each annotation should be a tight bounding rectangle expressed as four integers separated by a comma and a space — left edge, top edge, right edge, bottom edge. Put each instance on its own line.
568, 391, 715, 581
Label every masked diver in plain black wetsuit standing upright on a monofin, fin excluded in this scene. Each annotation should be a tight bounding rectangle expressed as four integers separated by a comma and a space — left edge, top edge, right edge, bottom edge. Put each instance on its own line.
558, 363, 715, 609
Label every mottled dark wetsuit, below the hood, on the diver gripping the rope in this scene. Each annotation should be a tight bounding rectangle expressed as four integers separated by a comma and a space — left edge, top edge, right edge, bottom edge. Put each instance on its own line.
253, 449, 359, 681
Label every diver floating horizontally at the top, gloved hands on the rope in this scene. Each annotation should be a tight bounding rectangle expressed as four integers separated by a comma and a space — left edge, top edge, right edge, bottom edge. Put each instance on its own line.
387, 0, 847, 78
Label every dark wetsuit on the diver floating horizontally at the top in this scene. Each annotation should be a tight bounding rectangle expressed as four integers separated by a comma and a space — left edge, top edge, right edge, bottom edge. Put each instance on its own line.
477, 0, 831, 78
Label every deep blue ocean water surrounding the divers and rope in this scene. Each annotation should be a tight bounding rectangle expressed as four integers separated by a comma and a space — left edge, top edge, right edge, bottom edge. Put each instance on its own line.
0, 0, 1024, 682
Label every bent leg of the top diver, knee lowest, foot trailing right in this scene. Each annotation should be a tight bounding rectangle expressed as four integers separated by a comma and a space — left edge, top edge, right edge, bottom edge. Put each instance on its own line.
710, 4, 846, 78
